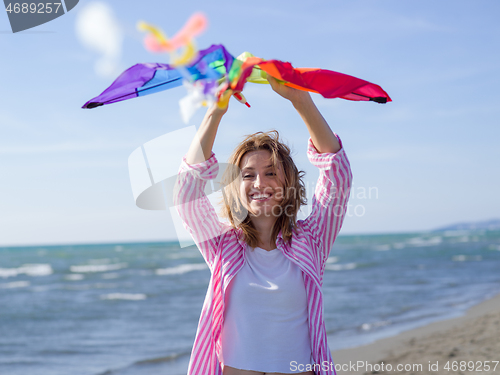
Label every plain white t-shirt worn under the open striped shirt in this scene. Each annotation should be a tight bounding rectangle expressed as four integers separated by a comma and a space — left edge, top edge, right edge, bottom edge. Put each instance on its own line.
222, 246, 311, 373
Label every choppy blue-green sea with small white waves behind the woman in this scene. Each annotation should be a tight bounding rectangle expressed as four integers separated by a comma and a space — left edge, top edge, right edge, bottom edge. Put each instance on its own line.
0, 230, 500, 375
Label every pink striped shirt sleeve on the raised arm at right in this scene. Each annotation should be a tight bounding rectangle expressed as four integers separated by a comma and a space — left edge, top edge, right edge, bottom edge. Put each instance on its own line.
304, 134, 352, 267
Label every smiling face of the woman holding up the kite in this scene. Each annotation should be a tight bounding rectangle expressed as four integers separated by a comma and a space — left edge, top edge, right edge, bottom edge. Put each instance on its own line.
240, 150, 284, 218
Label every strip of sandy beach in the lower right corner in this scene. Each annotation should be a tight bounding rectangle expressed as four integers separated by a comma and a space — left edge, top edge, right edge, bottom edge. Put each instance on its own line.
332, 294, 500, 375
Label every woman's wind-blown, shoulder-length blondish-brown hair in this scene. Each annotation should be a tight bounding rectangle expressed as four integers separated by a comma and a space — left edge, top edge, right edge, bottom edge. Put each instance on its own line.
220, 130, 307, 247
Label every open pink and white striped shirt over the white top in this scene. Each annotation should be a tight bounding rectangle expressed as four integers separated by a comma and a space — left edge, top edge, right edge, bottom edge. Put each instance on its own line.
174, 139, 352, 375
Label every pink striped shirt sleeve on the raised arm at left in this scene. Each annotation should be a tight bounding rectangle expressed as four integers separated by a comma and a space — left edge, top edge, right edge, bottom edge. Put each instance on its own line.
174, 152, 230, 269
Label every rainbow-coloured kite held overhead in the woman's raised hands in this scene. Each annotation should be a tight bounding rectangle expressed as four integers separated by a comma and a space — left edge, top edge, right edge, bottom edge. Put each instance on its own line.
83, 14, 391, 122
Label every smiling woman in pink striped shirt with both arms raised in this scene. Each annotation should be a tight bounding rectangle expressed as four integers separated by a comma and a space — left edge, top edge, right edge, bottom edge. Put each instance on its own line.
174, 77, 352, 375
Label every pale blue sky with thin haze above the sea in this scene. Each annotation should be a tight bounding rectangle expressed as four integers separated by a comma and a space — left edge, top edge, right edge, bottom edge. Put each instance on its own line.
0, 0, 500, 245
